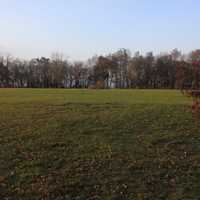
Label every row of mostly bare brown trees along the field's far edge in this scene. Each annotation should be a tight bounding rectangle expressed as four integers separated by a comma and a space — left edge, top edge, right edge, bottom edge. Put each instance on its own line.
0, 49, 200, 89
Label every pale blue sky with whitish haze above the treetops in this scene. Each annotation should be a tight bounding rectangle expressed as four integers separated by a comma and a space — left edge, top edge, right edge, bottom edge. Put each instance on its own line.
0, 0, 200, 60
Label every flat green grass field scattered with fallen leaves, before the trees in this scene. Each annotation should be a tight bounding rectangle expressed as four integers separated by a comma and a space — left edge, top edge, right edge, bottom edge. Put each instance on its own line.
0, 89, 200, 200
